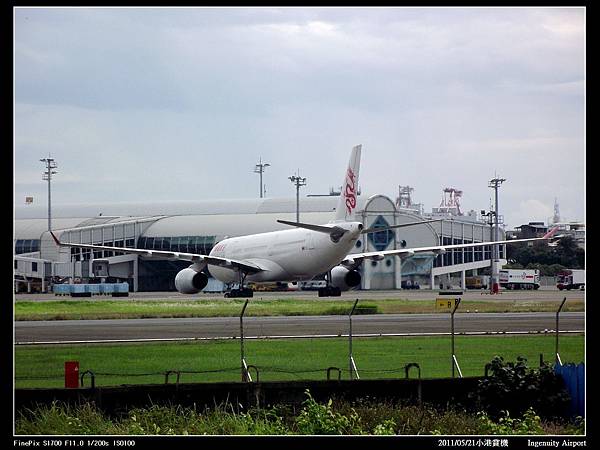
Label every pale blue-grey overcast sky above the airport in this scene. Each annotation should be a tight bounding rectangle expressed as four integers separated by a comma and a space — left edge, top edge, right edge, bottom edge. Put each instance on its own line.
14, 8, 585, 228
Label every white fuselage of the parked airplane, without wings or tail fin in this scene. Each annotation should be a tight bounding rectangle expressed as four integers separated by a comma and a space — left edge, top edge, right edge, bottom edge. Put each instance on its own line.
208, 222, 362, 283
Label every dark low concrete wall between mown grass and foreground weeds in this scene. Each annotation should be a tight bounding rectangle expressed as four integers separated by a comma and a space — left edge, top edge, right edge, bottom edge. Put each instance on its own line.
15, 374, 481, 413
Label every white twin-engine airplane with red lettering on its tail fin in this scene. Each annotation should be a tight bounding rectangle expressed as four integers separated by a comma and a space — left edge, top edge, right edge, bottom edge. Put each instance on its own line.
50, 145, 556, 298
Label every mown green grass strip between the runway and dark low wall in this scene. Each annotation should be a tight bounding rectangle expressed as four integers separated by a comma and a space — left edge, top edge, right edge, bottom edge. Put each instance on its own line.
15, 334, 584, 388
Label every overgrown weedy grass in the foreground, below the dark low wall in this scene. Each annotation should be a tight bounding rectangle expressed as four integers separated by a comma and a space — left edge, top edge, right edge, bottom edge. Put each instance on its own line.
15, 398, 585, 436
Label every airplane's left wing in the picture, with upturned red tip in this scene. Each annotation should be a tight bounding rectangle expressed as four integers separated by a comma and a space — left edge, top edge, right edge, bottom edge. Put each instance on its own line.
50, 231, 266, 273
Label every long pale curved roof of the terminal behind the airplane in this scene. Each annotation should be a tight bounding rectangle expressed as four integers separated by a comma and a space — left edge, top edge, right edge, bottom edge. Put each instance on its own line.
14, 196, 367, 239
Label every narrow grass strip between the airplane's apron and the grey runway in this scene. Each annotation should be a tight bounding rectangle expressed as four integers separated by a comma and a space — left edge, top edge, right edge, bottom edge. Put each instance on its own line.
15, 297, 584, 320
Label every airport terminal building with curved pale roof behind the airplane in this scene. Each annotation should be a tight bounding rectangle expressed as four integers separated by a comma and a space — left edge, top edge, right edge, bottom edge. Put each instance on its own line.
13, 195, 506, 292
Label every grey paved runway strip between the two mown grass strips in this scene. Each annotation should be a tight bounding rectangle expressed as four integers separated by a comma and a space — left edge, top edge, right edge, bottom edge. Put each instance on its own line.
14, 312, 585, 344
